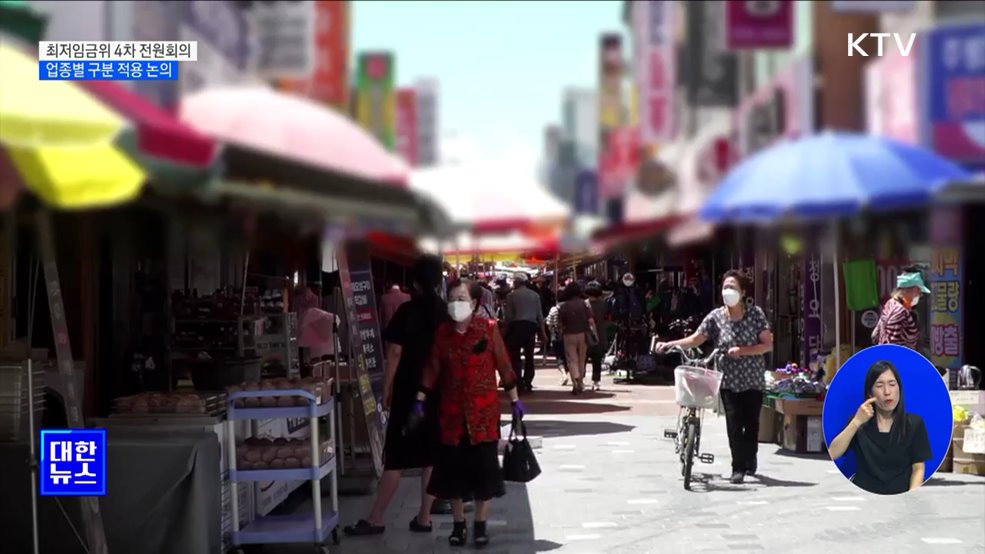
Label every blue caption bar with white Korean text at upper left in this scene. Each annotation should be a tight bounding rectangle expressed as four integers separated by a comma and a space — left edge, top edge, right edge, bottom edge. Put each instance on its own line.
38, 60, 178, 81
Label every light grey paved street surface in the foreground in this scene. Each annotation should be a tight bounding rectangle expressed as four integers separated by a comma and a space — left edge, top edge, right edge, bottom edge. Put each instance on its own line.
280, 364, 985, 554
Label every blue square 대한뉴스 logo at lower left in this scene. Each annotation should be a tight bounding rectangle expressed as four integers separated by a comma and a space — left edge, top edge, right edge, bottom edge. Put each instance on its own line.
41, 429, 106, 496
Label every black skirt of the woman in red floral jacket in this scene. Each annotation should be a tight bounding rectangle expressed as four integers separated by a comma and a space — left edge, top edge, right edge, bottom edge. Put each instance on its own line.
428, 437, 506, 501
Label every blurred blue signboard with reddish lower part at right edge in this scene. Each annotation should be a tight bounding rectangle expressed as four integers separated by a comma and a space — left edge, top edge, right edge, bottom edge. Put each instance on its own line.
922, 23, 985, 165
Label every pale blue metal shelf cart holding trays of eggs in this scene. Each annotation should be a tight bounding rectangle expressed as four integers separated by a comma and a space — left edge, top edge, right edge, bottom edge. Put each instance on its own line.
226, 389, 339, 553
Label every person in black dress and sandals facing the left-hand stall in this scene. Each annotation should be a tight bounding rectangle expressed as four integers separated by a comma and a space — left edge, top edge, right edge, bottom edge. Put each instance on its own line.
343, 256, 448, 536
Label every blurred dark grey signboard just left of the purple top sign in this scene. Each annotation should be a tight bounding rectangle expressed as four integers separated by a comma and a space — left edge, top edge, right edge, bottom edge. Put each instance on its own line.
681, 2, 739, 108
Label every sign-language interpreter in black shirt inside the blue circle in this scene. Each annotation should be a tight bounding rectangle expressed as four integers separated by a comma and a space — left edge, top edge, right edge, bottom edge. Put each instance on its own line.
828, 361, 934, 494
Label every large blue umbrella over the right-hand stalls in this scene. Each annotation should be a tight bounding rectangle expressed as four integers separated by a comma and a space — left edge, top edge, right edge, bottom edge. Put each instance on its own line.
700, 132, 971, 221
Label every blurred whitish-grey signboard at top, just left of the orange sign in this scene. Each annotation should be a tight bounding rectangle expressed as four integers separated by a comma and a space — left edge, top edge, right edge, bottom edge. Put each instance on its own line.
251, 0, 322, 79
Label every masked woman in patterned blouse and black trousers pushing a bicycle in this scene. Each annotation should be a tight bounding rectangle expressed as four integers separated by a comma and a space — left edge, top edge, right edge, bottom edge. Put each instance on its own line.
657, 269, 773, 484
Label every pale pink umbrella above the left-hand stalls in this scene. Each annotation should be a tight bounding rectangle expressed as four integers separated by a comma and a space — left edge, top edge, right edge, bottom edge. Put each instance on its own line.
180, 88, 409, 184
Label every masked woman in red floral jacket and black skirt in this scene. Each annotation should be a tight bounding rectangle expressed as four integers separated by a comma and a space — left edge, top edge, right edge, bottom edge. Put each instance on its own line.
415, 280, 523, 547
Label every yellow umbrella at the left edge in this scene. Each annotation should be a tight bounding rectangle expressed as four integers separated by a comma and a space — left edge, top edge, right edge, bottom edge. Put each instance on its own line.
0, 41, 146, 208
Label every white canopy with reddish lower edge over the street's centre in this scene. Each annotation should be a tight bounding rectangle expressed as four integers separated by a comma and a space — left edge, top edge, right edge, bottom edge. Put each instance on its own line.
410, 163, 570, 234
